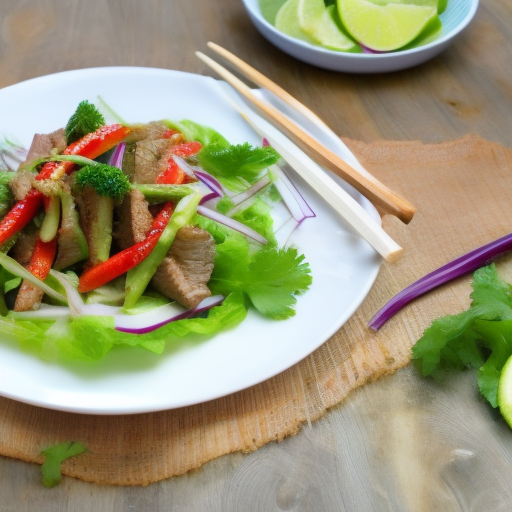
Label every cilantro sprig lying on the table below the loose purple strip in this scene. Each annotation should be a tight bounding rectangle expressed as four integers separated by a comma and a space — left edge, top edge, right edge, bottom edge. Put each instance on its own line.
412, 264, 512, 407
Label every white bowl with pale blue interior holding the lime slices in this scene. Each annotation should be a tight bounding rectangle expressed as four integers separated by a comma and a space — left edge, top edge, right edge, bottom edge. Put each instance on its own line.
242, 0, 479, 73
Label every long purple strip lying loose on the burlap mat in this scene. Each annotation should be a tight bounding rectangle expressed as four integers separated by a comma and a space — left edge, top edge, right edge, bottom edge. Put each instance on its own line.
368, 233, 512, 330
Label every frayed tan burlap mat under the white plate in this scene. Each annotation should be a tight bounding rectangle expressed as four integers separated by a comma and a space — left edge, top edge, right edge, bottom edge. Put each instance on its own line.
0, 136, 512, 485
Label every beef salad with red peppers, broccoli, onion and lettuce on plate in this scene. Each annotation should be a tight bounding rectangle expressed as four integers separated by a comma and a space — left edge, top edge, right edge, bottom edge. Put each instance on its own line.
0, 101, 314, 360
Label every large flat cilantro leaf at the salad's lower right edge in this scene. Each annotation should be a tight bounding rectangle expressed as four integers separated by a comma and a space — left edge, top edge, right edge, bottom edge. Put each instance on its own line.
210, 237, 312, 320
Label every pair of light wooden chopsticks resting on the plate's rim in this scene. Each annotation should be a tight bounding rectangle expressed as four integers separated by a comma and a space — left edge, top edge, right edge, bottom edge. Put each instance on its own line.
196, 43, 415, 261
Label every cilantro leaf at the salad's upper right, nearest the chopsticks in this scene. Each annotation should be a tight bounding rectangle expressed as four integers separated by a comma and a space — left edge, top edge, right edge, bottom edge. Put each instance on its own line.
197, 142, 280, 191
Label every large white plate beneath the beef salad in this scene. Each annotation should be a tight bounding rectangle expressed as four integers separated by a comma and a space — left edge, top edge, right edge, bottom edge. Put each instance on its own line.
0, 67, 381, 414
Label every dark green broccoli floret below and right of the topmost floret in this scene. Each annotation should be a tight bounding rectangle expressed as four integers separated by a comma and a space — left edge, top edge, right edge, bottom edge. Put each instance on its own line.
75, 164, 130, 200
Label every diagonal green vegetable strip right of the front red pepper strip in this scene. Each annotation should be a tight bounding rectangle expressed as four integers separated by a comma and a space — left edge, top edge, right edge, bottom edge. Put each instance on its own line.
124, 192, 201, 309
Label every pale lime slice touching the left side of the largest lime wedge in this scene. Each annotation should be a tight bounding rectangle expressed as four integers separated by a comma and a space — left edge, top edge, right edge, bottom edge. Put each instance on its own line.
298, 0, 360, 52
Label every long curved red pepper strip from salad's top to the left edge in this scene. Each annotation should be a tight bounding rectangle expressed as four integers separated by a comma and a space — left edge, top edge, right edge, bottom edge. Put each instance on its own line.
0, 124, 130, 246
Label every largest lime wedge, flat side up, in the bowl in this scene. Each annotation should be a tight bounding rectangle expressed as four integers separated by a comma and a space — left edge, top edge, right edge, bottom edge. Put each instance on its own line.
338, 0, 437, 51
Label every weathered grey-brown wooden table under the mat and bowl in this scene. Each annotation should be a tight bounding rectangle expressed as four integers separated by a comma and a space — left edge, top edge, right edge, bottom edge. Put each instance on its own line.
0, 0, 512, 512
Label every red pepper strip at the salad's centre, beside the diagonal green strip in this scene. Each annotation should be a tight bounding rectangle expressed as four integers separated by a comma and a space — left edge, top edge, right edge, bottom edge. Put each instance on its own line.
78, 203, 174, 293
